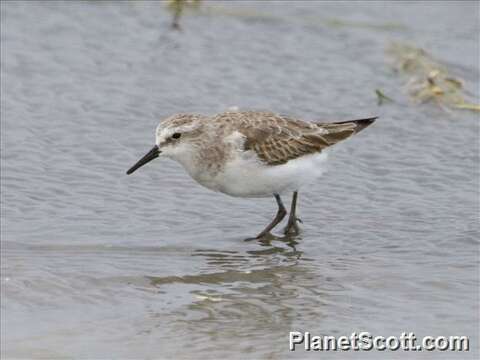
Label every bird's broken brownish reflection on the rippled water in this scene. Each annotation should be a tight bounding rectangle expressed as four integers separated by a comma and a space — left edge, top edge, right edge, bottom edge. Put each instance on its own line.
141, 236, 325, 352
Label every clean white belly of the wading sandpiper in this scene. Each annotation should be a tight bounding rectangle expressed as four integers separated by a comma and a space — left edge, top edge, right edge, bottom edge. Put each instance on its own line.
200, 153, 327, 197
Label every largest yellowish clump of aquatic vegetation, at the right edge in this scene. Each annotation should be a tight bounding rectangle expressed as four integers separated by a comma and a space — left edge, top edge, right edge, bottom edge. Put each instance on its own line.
387, 43, 480, 111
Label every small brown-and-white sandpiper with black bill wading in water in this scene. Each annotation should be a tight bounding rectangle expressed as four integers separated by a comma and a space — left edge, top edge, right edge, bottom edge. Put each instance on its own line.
127, 111, 376, 239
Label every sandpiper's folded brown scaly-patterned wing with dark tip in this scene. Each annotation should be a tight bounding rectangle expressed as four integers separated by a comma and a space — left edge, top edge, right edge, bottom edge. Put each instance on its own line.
234, 113, 376, 165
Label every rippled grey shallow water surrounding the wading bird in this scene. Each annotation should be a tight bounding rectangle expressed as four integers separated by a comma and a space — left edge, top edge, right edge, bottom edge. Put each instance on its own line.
1, 1, 480, 359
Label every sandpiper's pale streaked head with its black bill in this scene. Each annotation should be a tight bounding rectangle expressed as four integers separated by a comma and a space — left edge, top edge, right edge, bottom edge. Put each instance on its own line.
127, 114, 203, 174
